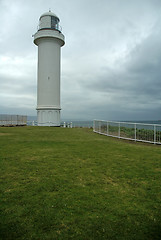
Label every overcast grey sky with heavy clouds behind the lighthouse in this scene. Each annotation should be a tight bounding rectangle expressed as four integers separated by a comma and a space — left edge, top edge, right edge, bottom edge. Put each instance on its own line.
0, 0, 161, 121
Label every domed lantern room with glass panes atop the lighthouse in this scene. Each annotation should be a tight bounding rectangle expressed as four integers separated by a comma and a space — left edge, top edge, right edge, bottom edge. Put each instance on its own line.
39, 11, 61, 32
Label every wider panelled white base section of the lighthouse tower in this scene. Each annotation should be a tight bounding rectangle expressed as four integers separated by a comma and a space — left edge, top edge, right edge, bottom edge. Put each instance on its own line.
37, 109, 60, 127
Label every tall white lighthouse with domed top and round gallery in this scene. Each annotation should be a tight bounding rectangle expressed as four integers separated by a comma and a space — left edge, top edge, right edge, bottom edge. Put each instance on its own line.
34, 11, 65, 126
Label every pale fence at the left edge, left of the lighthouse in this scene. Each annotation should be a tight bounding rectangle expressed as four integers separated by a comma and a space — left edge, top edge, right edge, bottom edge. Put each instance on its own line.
0, 114, 27, 126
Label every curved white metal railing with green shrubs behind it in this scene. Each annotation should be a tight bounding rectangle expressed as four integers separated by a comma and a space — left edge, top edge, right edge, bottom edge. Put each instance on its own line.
93, 120, 161, 144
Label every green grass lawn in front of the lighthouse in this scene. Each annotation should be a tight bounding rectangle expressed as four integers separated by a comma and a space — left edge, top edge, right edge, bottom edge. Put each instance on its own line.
0, 127, 161, 240
